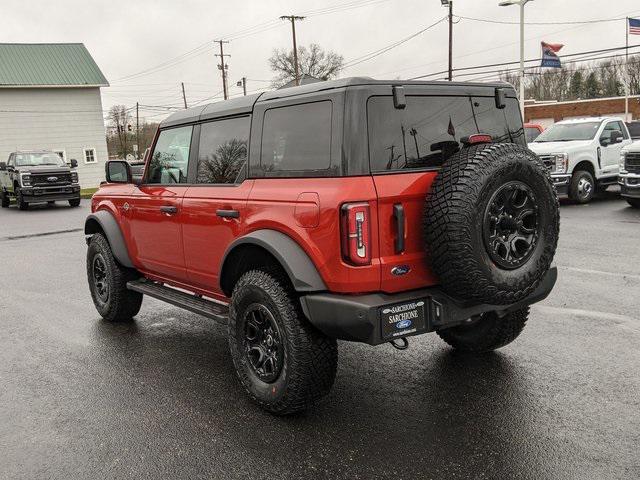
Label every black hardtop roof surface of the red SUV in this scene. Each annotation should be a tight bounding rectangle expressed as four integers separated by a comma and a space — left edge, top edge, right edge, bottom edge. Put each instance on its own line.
160, 77, 515, 128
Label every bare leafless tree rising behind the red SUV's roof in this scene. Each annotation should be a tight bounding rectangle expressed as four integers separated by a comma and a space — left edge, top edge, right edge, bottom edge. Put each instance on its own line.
269, 43, 344, 87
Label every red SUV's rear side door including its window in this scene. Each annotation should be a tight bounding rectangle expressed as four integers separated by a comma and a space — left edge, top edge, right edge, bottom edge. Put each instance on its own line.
182, 116, 253, 293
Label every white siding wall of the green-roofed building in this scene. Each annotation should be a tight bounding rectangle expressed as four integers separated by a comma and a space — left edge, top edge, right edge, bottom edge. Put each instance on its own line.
0, 88, 108, 188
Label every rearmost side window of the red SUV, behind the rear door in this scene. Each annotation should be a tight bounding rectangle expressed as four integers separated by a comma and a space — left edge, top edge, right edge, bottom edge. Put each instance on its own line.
252, 101, 337, 177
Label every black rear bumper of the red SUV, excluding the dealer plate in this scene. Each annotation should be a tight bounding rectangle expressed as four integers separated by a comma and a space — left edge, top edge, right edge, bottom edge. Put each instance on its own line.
300, 267, 558, 345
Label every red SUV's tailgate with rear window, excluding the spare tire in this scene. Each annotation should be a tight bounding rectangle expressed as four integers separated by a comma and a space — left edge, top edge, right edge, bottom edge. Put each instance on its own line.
367, 89, 525, 292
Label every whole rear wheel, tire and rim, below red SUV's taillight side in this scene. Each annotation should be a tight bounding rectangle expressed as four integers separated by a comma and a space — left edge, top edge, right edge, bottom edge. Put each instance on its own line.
228, 269, 338, 415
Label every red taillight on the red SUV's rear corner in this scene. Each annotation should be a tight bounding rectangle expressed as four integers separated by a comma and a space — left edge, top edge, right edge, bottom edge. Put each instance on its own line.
340, 202, 371, 266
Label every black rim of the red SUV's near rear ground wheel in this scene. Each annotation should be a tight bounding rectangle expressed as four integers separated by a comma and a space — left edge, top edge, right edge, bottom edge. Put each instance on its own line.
243, 303, 284, 383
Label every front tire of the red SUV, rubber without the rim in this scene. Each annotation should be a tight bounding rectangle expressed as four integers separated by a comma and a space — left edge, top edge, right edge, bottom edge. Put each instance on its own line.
87, 233, 143, 322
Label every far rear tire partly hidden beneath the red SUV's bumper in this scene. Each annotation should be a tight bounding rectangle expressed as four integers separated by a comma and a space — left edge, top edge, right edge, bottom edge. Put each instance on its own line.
437, 307, 529, 353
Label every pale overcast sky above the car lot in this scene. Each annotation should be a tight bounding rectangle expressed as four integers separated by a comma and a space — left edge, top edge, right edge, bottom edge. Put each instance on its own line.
0, 0, 640, 120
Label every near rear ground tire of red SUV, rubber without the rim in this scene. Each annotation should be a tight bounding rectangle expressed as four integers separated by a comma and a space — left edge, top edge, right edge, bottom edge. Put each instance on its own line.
228, 269, 338, 415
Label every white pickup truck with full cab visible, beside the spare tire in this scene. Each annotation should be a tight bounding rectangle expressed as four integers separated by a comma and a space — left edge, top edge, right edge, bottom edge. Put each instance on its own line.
529, 117, 631, 203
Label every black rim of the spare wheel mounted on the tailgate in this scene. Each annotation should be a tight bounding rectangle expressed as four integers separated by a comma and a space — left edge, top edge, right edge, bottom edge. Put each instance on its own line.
483, 181, 538, 269
